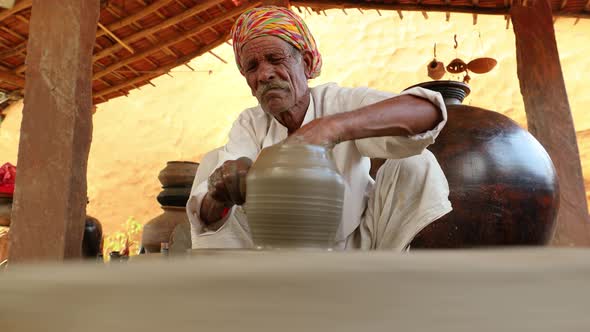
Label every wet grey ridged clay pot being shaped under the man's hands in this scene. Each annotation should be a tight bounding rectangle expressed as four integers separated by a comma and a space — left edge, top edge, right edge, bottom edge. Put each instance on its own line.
245, 144, 344, 248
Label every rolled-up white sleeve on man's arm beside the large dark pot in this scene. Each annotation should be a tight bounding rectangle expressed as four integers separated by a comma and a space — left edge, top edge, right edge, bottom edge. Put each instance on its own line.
355, 87, 447, 159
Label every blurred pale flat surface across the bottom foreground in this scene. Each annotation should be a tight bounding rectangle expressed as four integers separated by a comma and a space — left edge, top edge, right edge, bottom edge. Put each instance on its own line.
0, 249, 590, 332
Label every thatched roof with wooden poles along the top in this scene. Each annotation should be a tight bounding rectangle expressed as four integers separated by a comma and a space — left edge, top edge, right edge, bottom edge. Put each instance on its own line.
0, 0, 590, 105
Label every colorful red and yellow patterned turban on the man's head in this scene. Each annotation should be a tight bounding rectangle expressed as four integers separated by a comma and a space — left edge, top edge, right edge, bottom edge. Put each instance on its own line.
231, 6, 322, 79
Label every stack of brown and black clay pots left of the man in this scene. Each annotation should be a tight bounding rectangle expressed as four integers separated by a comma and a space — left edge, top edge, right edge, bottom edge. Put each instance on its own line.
141, 161, 199, 253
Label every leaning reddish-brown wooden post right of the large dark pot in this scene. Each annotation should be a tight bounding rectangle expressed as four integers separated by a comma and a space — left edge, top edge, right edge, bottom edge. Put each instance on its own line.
510, 0, 590, 246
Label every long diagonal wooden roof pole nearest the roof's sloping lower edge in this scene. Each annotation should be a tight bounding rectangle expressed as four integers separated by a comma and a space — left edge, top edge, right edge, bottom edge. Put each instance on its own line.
93, 2, 260, 79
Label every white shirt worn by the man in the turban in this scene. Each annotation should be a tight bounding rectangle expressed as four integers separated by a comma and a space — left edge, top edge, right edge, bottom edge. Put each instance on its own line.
187, 83, 450, 248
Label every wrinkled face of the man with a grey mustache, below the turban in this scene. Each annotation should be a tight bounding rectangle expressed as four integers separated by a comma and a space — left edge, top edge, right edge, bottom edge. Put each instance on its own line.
241, 36, 311, 117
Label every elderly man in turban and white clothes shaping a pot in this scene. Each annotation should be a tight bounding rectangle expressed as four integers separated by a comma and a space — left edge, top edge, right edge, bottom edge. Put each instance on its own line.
187, 7, 451, 251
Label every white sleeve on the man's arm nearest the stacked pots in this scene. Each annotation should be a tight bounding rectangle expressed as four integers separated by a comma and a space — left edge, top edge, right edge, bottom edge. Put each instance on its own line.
186, 113, 259, 249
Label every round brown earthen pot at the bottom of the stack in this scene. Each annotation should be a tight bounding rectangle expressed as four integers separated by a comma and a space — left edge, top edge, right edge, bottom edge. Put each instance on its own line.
141, 206, 189, 253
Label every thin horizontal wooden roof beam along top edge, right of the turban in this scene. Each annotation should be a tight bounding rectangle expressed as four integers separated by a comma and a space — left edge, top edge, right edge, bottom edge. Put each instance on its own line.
291, 0, 590, 18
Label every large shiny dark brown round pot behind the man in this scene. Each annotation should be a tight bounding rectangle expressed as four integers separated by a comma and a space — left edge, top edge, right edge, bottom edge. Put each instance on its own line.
411, 81, 559, 249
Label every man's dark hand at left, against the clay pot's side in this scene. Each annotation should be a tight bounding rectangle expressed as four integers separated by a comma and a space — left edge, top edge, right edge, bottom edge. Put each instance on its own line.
200, 157, 252, 224
